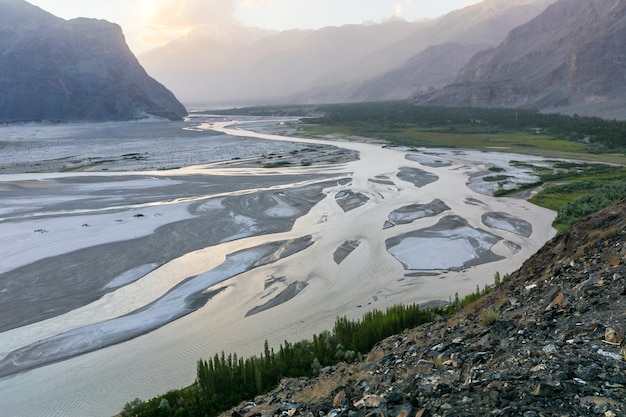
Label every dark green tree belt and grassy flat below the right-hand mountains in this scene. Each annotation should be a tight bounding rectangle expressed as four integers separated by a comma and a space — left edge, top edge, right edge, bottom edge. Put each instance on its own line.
306, 101, 626, 154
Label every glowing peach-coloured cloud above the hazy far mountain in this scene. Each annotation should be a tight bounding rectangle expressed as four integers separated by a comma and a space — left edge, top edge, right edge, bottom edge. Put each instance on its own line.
141, 0, 242, 46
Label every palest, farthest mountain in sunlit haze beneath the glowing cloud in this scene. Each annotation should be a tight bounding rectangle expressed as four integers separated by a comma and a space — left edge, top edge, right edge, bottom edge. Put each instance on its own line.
139, 21, 414, 104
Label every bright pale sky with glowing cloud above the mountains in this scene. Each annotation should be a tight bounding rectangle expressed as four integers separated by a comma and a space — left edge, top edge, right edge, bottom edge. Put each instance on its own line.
28, 0, 482, 54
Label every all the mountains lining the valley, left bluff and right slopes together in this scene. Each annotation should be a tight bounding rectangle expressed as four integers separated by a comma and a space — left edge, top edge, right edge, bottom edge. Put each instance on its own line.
0, 0, 626, 123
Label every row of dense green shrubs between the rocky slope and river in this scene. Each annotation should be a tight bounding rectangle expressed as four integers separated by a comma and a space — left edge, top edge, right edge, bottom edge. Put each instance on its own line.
120, 282, 499, 417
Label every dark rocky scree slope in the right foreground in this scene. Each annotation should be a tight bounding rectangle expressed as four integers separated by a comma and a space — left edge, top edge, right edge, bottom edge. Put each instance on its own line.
229, 200, 626, 417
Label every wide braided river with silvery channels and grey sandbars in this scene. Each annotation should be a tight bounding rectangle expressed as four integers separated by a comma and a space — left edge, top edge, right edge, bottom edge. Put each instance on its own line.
0, 115, 555, 417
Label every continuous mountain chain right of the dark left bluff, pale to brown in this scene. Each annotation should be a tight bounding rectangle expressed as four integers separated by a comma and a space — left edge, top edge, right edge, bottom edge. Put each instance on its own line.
139, 0, 626, 119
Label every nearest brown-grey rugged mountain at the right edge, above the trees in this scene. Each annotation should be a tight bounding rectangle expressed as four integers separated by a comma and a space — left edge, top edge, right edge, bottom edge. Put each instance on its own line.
415, 0, 626, 119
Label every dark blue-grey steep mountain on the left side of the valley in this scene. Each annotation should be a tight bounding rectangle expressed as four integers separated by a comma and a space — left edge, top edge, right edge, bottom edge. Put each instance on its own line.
0, 0, 187, 123
